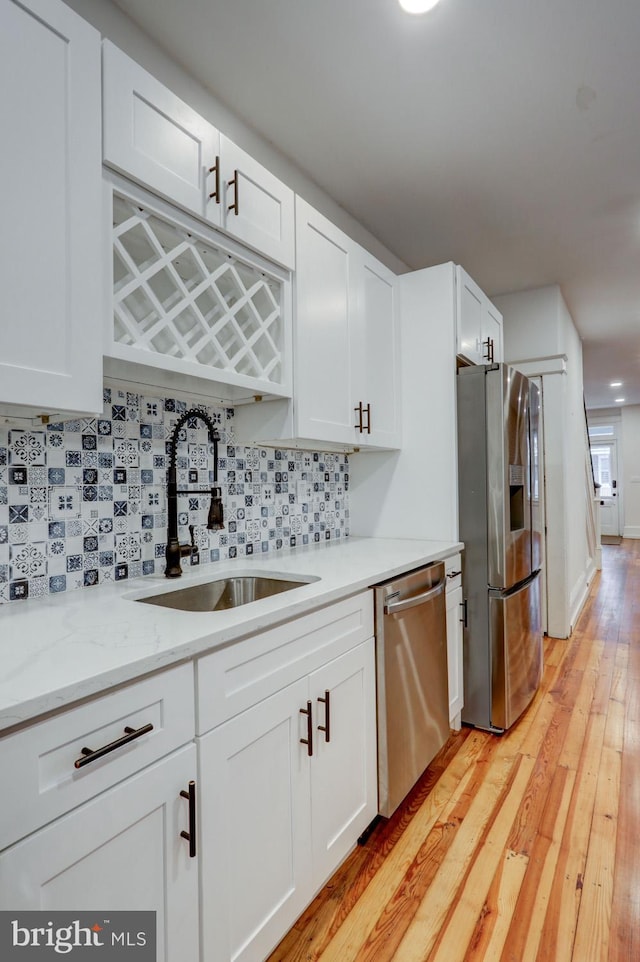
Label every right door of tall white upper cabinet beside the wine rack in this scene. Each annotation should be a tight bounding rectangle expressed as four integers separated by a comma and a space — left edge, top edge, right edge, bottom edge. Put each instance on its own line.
352, 248, 400, 448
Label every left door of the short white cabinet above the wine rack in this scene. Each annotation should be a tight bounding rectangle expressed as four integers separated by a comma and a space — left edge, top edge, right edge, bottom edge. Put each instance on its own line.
102, 40, 221, 225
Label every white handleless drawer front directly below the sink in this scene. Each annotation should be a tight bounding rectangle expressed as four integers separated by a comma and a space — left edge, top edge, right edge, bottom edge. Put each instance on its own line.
196, 591, 373, 735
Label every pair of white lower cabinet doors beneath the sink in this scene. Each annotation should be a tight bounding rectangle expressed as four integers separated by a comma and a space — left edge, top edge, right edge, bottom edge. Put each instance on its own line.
198, 592, 377, 962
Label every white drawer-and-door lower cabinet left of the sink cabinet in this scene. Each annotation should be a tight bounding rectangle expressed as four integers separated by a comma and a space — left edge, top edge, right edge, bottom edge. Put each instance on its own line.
0, 664, 200, 962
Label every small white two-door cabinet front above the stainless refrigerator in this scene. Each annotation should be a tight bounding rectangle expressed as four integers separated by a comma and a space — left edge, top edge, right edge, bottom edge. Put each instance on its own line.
456, 266, 502, 364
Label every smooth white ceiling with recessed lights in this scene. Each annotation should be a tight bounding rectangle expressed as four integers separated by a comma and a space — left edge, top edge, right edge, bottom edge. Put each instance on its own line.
117, 0, 640, 407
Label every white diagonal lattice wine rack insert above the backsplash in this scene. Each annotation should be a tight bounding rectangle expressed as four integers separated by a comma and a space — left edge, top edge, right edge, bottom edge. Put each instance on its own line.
113, 194, 283, 384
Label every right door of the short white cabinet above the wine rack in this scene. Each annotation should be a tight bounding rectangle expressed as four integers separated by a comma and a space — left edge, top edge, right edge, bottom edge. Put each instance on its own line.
220, 135, 295, 268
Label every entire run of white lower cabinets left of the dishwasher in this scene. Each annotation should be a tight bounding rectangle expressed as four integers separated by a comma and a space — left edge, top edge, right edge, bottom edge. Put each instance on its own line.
0, 591, 378, 962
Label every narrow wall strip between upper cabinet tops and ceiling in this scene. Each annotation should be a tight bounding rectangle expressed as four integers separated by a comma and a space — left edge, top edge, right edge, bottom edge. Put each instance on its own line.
65, 0, 407, 273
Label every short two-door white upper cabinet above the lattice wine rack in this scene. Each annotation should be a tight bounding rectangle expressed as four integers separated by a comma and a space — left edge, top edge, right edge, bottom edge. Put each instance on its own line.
103, 40, 294, 268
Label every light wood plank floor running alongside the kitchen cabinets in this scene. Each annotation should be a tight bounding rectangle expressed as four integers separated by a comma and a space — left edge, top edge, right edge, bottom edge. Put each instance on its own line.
270, 541, 640, 962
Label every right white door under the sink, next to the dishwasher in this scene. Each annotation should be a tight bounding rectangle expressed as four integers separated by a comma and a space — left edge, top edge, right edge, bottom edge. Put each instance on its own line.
309, 638, 378, 888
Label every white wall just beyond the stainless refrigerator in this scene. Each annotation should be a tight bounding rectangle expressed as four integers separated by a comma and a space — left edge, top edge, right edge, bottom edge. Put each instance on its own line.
493, 285, 595, 637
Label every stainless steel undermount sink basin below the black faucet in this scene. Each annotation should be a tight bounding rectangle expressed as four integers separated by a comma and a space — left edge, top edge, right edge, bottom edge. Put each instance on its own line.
135, 575, 309, 611
